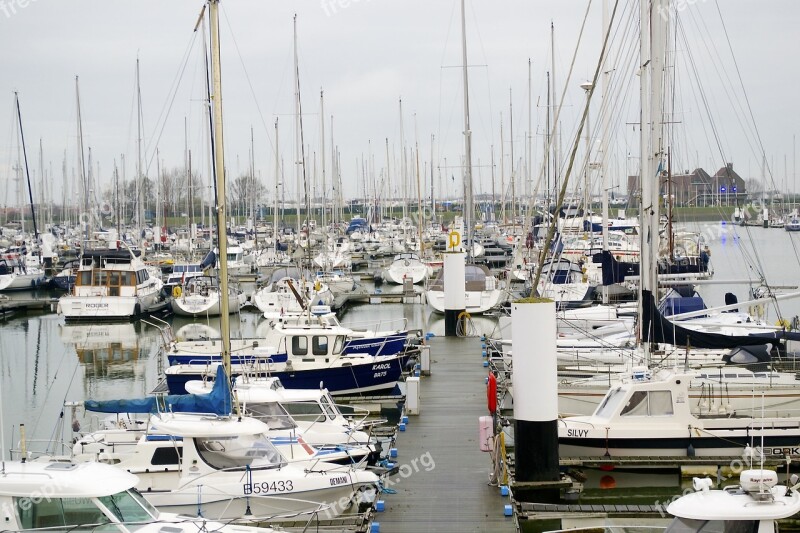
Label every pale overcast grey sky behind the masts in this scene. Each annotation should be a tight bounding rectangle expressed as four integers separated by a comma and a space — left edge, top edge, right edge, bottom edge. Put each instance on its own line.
0, 0, 800, 210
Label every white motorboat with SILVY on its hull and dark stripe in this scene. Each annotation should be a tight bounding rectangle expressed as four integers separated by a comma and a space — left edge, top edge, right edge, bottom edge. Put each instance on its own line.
558, 371, 800, 457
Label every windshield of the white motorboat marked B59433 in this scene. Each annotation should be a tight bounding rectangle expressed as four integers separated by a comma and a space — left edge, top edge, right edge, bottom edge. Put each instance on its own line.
194, 433, 286, 470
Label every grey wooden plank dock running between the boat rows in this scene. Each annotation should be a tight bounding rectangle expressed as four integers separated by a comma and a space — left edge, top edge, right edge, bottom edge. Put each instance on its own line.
373, 337, 516, 533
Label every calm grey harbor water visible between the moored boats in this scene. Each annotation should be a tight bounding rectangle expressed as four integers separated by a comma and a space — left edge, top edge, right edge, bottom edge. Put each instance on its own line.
0, 220, 800, 520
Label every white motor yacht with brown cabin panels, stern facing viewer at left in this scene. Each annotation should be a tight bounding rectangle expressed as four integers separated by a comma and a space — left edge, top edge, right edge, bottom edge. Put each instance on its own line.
58, 244, 169, 320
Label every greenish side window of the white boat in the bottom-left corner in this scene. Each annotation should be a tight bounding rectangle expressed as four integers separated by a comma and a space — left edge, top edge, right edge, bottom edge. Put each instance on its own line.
14, 492, 112, 531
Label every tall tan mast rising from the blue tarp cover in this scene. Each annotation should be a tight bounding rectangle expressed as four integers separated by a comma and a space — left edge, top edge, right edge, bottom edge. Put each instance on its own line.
208, 0, 233, 386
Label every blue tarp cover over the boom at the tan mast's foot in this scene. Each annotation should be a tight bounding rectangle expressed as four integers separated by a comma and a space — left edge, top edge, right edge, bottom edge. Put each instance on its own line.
83, 365, 233, 416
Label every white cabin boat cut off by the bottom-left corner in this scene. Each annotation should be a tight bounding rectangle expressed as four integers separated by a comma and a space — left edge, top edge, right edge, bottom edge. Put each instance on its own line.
0, 461, 273, 533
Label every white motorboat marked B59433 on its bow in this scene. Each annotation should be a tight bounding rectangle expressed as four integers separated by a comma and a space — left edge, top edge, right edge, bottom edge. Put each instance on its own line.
72, 412, 378, 521
